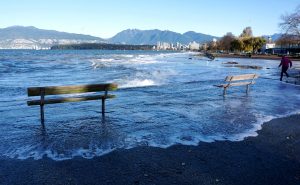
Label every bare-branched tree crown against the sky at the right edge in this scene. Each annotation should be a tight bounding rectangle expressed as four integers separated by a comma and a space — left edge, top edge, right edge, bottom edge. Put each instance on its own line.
279, 6, 300, 38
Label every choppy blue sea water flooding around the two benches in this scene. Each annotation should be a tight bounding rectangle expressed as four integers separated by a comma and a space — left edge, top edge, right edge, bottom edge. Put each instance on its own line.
0, 50, 300, 160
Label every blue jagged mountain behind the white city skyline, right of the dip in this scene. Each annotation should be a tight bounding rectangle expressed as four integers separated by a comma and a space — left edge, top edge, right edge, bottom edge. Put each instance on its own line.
108, 29, 218, 45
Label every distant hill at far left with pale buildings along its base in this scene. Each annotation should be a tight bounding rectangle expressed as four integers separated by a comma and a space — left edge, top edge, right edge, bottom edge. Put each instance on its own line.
0, 26, 105, 49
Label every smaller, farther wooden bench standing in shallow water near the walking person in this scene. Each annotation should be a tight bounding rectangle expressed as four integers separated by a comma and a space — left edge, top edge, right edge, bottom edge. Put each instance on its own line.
215, 74, 258, 96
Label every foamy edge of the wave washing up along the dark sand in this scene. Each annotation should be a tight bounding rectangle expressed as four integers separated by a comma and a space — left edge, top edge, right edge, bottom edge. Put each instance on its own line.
3, 111, 300, 161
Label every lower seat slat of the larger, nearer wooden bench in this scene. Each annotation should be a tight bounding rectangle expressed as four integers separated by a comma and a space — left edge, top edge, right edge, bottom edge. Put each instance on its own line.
27, 94, 116, 106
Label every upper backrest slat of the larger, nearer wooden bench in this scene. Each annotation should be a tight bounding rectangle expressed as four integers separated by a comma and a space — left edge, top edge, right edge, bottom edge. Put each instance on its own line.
27, 84, 118, 96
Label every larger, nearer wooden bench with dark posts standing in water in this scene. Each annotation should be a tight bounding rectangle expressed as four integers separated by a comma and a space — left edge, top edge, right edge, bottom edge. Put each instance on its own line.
27, 84, 118, 126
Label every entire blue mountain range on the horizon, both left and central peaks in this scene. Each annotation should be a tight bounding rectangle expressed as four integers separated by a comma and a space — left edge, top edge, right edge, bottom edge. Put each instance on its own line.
0, 26, 282, 49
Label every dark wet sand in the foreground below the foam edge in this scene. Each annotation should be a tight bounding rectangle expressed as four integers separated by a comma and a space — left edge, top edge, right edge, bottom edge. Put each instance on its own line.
0, 114, 300, 185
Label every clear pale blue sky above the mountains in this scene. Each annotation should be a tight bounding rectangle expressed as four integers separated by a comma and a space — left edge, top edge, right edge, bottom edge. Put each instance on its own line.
0, 0, 300, 38
